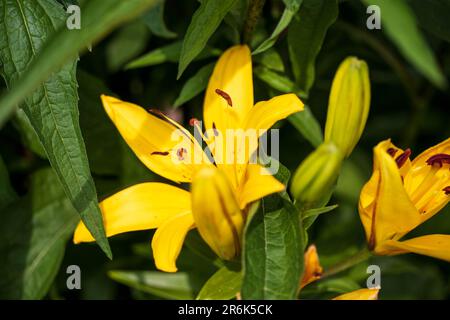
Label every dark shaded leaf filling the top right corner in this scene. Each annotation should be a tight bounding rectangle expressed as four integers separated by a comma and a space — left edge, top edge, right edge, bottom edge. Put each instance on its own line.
408, 0, 450, 42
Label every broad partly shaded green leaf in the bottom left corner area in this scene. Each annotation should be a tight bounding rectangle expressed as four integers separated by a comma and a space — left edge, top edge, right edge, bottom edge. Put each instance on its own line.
0, 169, 79, 299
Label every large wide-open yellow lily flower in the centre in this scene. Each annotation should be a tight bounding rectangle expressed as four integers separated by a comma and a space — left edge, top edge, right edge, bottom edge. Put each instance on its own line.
74, 46, 303, 272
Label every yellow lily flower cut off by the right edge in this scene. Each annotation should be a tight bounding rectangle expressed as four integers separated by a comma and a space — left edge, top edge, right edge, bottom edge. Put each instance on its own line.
359, 138, 450, 262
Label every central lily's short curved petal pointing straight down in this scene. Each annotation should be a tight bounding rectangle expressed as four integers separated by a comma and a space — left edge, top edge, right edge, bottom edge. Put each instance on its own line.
152, 212, 194, 272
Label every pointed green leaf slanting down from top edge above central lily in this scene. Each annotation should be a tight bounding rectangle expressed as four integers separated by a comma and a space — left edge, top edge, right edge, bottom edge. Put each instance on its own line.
177, 0, 236, 79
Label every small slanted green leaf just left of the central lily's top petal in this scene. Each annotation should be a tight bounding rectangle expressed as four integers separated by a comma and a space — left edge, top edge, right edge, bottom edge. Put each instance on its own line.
174, 63, 215, 108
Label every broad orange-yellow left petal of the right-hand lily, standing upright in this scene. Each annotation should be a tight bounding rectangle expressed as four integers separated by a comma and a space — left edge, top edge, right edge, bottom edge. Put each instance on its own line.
359, 140, 421, 251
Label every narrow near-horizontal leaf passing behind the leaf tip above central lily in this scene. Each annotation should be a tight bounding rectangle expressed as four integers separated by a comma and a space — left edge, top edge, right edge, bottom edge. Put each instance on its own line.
125, 41, 220, 69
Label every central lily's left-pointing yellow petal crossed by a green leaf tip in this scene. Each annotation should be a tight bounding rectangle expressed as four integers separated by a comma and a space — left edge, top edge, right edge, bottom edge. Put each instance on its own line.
73, 182, 191, 243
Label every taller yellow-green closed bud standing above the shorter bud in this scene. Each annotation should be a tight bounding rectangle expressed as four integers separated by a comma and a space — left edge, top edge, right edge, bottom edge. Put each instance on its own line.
325, 57, 370, 157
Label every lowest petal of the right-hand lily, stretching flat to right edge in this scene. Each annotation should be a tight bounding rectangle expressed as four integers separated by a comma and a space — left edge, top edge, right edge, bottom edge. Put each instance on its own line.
383, 234, 450, 262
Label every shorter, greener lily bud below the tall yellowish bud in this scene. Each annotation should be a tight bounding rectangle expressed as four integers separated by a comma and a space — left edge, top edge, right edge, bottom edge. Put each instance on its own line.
291, 143, 344, 209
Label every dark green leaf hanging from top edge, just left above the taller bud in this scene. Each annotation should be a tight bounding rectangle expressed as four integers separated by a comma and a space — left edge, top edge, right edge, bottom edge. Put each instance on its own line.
288, 0, 338, 94
